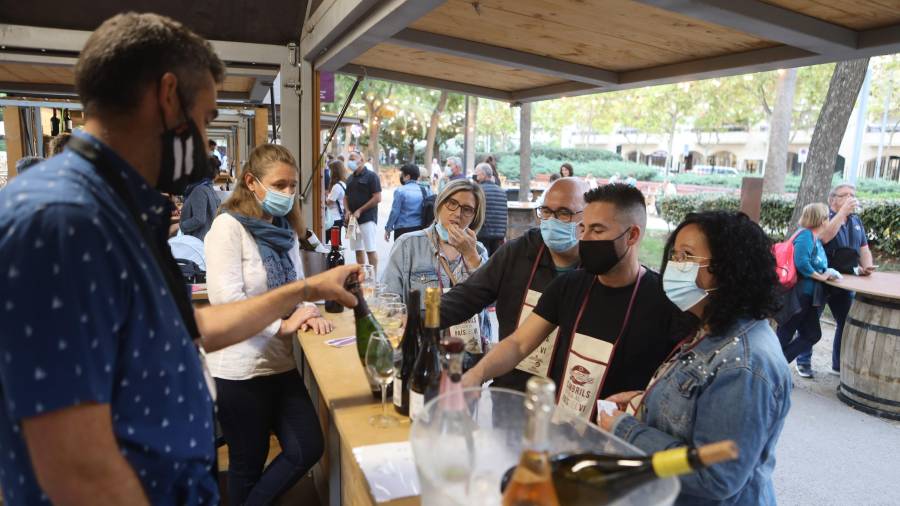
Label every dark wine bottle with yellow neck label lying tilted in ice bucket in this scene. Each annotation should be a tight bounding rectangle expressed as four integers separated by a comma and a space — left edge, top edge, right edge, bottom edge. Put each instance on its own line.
553, 441, 738, 506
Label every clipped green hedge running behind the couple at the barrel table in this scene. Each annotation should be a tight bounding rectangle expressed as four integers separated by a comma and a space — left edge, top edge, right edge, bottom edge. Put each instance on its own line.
658, 195, 900, 258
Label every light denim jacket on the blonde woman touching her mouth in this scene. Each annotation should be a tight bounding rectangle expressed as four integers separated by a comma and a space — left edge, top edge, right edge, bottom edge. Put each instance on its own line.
381, 226, 491, 344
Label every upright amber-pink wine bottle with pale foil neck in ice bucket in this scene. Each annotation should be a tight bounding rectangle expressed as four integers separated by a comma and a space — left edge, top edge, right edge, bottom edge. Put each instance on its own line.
503, 376, 560, 506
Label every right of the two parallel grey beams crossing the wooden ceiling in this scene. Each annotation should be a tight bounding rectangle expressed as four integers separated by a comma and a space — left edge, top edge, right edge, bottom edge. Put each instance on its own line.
637, 0, 858, 54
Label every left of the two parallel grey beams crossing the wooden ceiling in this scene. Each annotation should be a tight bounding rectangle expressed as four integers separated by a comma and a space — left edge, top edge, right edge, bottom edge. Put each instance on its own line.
389, 28, 619, 86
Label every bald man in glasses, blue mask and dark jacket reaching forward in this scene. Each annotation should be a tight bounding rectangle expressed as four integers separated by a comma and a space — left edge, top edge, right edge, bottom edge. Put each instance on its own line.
441, 178, 590, 392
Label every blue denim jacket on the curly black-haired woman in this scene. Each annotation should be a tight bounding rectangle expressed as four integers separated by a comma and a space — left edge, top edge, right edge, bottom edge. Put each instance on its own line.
612, 319, 792, 506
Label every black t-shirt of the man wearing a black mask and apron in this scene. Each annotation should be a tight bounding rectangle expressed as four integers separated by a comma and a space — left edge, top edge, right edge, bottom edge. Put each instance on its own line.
534, 269, 685, 399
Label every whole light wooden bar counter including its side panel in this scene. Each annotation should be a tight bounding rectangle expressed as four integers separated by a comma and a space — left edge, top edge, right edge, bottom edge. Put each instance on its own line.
294, 310, 419, 506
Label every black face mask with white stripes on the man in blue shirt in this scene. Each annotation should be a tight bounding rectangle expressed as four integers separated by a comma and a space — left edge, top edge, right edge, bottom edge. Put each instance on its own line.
156, 97, 209, 195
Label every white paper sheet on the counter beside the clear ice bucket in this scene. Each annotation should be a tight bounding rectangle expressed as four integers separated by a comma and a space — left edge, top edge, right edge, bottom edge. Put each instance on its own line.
353, 441, 421, 502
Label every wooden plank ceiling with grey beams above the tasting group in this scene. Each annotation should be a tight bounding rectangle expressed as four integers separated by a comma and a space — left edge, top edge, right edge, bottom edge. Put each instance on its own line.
300, 0, 900, 102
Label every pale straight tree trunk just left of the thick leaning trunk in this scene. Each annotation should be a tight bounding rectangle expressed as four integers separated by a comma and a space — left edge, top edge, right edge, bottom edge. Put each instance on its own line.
763, 68, 797, 193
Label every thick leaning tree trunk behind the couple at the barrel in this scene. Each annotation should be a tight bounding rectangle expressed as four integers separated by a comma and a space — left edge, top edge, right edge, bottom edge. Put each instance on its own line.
790, 58, 869, 223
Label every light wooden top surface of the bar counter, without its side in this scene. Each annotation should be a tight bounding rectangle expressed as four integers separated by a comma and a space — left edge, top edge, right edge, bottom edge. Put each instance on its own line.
298, 309, 419, 506
